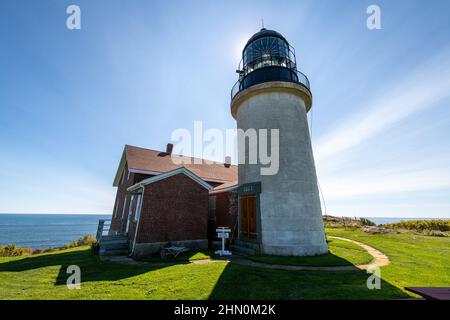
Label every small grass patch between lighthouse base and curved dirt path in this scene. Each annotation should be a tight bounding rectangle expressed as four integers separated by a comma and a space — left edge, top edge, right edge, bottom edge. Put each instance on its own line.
250, 239, 372, 266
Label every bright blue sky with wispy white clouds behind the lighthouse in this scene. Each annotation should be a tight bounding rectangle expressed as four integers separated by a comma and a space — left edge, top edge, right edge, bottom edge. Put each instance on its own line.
0, 0, 450, 217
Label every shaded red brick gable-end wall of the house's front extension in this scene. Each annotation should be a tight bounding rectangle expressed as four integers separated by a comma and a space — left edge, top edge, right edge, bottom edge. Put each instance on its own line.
136, 173, 208, 243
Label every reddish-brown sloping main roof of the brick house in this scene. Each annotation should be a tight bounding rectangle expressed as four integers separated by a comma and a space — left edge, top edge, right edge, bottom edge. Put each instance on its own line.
114, 145, 237, 186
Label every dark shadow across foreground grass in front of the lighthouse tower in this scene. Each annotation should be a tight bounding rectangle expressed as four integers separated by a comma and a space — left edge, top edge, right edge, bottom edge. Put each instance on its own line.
209, 263, 410, 300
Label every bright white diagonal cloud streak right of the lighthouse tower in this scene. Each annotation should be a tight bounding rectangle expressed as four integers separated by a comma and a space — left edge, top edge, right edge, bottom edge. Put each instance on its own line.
314, 50, 450, 161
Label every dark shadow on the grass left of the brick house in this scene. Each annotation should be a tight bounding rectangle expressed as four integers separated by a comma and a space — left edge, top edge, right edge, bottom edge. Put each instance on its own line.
0, 249, 164, 285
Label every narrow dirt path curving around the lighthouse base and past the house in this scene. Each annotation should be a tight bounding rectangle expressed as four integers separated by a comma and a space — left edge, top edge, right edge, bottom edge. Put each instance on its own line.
101, 236, 390, 271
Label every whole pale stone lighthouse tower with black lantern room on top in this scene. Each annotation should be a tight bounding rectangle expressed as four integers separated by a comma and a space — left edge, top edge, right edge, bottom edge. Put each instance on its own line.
231, 28, 328, 256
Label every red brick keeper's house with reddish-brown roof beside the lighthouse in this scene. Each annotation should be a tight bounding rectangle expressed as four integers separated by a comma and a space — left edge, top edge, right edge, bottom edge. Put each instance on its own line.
100, 144, 238, 257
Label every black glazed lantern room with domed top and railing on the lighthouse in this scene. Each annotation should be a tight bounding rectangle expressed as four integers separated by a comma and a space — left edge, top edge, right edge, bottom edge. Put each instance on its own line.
231, 28, 309, 99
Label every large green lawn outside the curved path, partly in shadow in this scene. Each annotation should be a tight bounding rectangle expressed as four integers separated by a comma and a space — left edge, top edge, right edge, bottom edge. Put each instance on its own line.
0, 229, 450, 299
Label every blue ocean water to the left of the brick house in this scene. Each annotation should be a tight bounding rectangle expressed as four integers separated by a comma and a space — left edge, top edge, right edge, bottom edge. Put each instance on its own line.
0, 214, 111, 249
